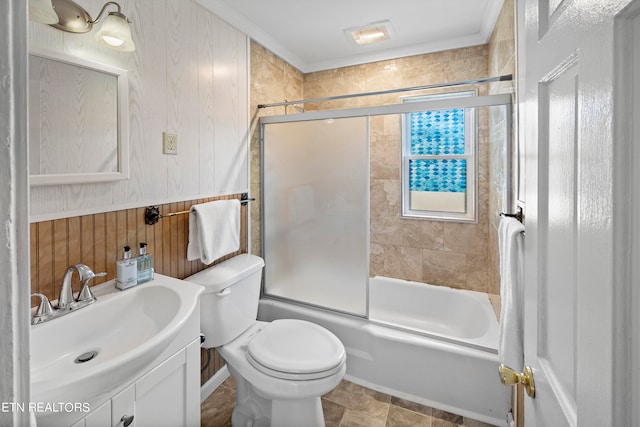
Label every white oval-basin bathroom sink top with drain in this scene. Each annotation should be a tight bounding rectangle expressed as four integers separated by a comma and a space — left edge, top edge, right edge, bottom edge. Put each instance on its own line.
31, 274, 203, 403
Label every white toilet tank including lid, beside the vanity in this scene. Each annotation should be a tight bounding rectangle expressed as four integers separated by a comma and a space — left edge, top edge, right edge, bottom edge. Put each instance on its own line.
184, 254, 264, 348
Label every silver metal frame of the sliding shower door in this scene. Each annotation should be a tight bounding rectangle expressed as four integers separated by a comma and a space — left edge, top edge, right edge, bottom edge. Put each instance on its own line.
259, 94, 517, 319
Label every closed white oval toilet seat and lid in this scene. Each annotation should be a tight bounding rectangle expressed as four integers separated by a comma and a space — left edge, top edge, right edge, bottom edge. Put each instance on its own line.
246, 319, 346, 380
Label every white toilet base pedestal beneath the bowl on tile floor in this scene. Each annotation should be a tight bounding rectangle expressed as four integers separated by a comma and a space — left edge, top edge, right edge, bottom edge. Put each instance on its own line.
227, 364, 325, 427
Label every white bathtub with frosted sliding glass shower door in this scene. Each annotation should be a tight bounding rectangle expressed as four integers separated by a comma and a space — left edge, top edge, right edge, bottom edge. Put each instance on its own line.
259, 76, 511, 425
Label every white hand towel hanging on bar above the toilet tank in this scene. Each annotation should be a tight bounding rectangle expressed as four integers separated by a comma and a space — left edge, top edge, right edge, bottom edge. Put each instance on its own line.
187, 199, 240, 264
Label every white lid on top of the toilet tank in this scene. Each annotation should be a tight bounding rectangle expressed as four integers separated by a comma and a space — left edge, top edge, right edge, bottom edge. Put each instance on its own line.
184, 254, 264, 293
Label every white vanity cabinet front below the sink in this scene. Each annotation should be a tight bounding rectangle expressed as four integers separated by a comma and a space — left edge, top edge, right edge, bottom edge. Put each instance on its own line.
72, 338, 200, 427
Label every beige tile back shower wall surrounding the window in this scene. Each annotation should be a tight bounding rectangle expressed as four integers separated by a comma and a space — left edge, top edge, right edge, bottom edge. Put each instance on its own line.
304, 45, 494, 292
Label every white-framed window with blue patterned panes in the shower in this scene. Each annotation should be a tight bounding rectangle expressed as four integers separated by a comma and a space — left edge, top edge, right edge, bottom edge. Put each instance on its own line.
402, 92, 477, 222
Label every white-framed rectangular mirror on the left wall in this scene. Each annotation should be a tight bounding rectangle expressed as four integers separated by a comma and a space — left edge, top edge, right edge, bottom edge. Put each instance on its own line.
29, 48, 129, 185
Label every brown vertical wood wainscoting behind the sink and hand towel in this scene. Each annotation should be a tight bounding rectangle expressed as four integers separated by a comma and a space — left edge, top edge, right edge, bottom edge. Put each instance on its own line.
31, 194, 248, 383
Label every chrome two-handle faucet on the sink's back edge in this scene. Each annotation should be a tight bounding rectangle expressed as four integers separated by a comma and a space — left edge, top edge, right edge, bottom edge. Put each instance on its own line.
31, 264, 107, 325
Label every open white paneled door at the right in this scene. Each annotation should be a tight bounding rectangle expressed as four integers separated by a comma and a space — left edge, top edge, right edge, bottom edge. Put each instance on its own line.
516, 0, 640, 427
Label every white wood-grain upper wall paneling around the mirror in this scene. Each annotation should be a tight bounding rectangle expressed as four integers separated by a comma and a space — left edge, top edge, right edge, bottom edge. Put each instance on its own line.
29, 0, 248, 222
